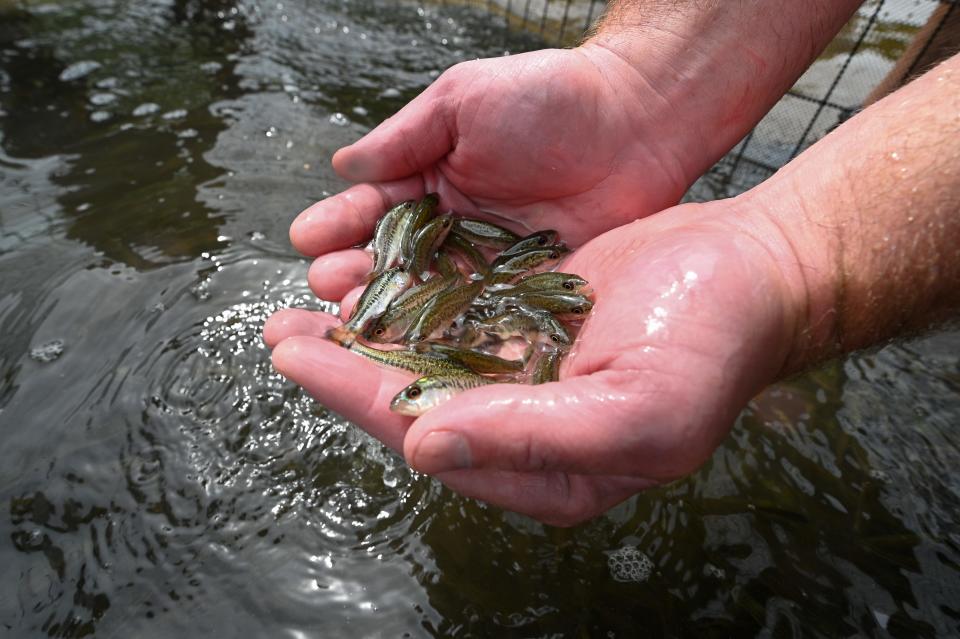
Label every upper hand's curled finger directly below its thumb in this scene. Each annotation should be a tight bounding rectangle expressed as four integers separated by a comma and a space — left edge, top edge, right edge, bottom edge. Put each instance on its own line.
290, 177, 424, 257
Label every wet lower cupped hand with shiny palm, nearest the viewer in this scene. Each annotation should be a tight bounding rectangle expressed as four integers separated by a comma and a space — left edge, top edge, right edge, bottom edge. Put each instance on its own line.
264, 200, 801, 525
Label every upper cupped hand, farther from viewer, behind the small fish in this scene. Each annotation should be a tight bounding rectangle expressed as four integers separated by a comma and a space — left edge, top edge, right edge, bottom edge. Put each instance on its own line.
290, 45, 713, 288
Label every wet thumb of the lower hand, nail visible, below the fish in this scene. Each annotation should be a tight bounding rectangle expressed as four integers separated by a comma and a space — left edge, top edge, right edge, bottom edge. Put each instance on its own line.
404, 371, 717, 479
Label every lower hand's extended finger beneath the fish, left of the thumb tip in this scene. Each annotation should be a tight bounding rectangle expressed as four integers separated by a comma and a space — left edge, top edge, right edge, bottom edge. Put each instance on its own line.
273, 335, 413, 451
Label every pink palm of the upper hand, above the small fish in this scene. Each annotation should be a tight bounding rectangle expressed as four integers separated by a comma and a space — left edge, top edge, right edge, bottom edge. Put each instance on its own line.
364, 49, 690, 244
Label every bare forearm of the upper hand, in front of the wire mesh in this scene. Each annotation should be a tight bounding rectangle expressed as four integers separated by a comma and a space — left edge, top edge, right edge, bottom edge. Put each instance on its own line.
583, 0, 862, 180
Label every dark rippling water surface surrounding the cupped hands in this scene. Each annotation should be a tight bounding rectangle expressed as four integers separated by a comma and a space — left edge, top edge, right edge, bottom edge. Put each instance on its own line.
0, 0, 960, 638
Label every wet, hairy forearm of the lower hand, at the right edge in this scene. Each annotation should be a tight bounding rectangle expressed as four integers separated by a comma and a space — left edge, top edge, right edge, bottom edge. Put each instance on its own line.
741, 56, 960, 373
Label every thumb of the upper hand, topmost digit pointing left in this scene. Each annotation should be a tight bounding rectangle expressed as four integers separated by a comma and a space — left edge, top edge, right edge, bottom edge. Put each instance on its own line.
333, 81, 456, 182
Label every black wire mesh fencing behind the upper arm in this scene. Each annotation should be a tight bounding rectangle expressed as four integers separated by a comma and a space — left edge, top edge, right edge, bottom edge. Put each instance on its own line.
448, 0, 960, 201
